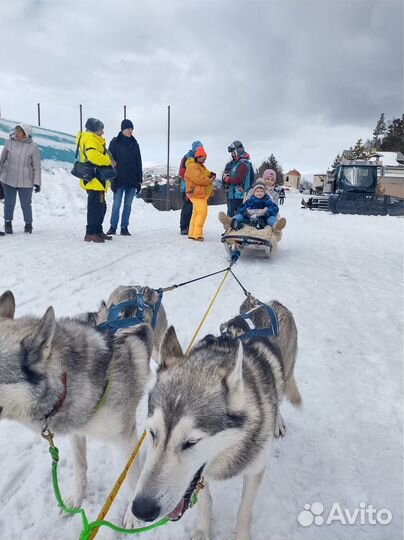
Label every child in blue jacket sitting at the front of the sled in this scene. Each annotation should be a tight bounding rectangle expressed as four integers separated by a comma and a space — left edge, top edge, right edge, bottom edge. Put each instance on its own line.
231, 182, 286, 231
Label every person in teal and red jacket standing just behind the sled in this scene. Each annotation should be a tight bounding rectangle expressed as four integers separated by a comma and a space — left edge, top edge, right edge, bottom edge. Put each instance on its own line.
222, 141, 255, 217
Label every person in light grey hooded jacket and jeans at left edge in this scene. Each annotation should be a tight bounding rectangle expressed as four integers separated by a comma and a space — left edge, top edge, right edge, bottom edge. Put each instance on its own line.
0, 124, 41, 234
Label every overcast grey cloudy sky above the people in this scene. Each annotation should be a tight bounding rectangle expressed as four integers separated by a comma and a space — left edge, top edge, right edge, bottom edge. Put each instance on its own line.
0, 0, 403, 173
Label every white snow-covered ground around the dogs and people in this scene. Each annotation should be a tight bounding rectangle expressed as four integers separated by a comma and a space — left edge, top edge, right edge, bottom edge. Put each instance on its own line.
0, 174, 403, 540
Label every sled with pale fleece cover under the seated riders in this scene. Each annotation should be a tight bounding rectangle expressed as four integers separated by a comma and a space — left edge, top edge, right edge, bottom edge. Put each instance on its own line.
218, 212, 286, 260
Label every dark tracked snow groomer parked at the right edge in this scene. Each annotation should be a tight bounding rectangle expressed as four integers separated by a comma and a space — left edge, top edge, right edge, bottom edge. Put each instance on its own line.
302, 159, 404, 216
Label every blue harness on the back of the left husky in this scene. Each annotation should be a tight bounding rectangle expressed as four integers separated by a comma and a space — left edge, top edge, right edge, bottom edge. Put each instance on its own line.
97, 289, 163, 333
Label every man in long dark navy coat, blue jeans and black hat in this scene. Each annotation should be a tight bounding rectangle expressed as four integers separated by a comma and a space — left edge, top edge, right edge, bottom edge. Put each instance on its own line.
107, 119, 143, 236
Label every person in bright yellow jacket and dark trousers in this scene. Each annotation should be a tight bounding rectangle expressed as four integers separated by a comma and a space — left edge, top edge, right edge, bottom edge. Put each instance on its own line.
77, 118, 114, 244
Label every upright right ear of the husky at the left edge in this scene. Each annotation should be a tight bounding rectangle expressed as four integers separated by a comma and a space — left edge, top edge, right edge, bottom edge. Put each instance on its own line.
21, 307, 56, 369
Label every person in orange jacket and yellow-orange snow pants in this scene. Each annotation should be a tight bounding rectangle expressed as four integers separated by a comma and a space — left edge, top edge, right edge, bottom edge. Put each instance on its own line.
185, 146, 216, 242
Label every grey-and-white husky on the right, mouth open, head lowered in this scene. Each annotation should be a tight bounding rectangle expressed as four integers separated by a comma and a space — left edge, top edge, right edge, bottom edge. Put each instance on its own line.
132, 298, 301, 540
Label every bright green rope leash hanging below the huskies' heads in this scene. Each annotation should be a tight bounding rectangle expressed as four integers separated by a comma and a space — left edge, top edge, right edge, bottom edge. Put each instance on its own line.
49, 446, 170, 540
